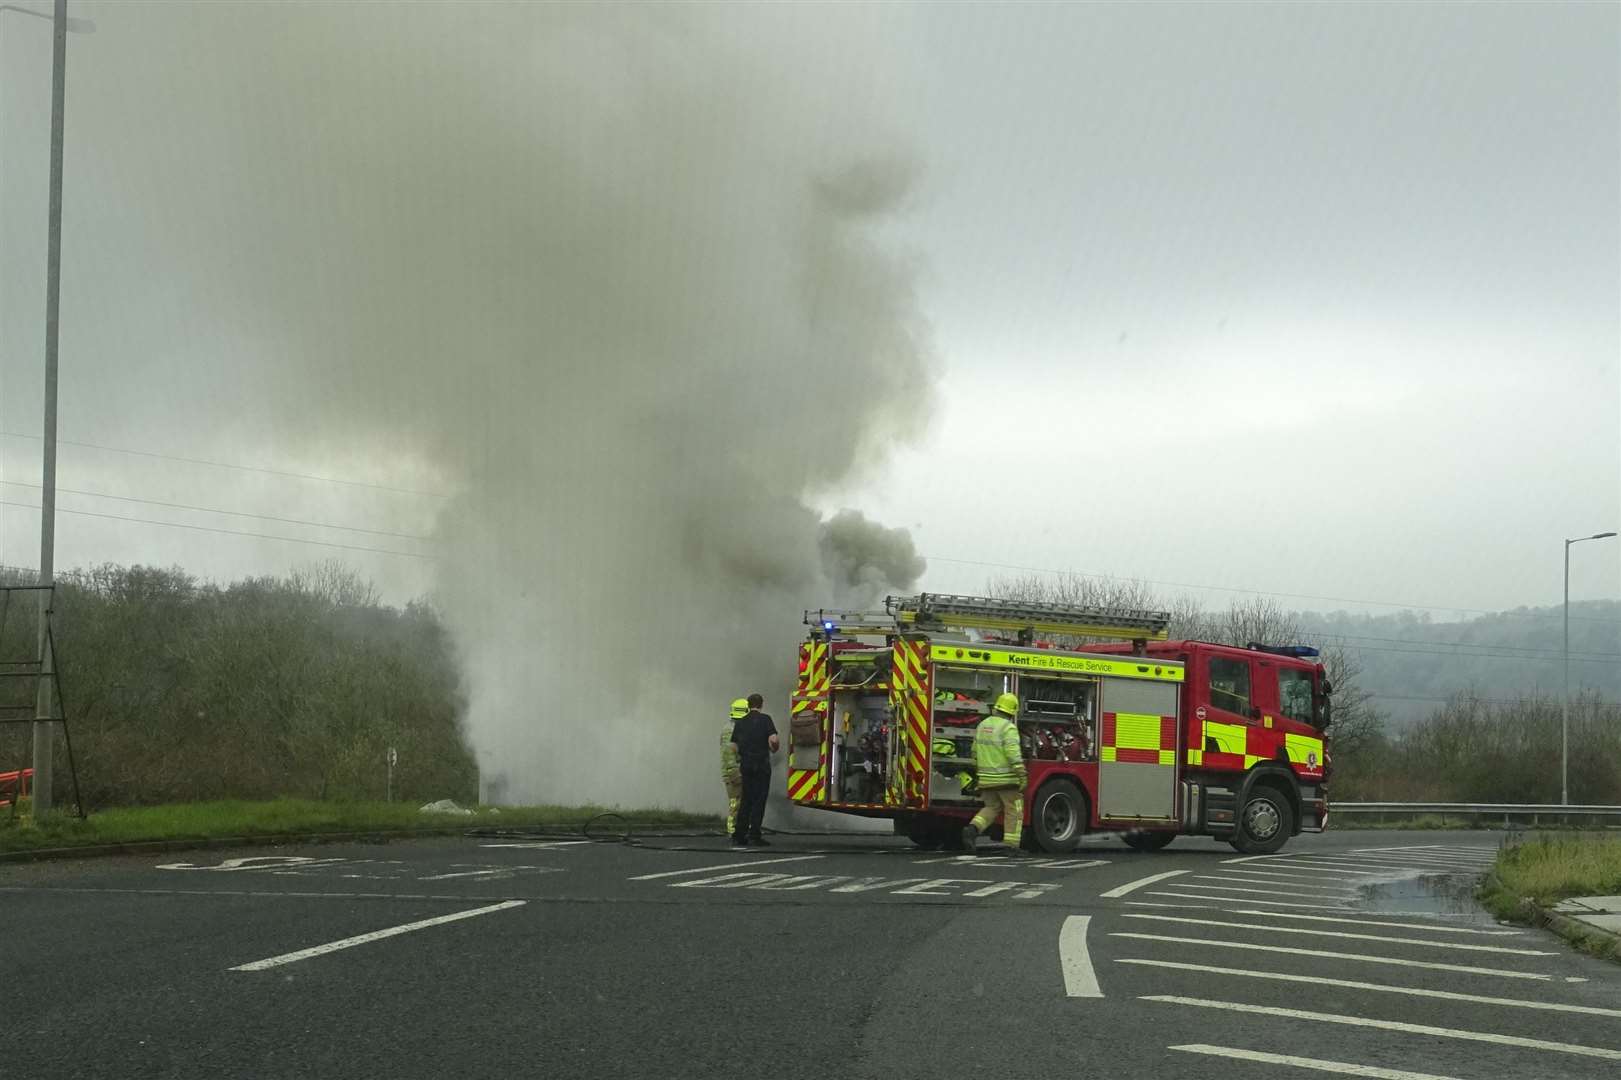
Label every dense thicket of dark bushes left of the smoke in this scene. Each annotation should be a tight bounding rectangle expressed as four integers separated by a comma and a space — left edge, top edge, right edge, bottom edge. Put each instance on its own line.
0, 564, 477, 808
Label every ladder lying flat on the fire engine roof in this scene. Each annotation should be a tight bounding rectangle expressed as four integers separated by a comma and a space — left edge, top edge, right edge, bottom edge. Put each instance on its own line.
883, 592, 1170, 641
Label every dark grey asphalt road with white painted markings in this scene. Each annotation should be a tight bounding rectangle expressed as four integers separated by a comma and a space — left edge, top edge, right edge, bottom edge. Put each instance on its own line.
0, 832, 1621, 1080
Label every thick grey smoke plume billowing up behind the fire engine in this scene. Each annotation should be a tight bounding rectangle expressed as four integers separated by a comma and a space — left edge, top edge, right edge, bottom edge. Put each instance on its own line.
38, 5, 932, 808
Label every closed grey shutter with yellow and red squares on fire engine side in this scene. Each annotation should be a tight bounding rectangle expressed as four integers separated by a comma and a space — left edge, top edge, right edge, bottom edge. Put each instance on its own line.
1097, 678, 1177, 821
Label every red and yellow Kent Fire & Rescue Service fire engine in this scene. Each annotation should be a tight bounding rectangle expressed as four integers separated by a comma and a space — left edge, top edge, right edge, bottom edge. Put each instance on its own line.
788, 594, 1332, 855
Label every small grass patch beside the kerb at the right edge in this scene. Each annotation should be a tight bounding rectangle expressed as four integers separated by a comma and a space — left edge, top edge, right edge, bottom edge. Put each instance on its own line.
1480, 834, 1621, 960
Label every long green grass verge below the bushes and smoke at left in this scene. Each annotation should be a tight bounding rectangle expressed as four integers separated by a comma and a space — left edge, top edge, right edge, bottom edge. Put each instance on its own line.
0, 799, 720, 853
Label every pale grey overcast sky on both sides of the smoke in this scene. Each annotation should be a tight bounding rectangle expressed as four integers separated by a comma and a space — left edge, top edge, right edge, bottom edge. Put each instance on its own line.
0, 2, 1621, 616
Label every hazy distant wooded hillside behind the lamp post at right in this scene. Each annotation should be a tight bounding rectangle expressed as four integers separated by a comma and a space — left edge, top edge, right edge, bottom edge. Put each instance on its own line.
1298, 600, 1621, 730
